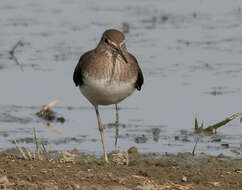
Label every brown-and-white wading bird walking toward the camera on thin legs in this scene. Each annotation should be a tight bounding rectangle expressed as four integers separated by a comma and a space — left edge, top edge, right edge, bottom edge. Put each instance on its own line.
73, 29, 144, 163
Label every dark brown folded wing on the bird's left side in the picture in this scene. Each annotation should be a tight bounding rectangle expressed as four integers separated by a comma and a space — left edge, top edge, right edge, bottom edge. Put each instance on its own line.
73, 51, 91, 86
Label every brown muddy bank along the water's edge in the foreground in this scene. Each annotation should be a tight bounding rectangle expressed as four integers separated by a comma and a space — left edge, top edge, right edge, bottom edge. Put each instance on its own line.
0, 150, 242, 190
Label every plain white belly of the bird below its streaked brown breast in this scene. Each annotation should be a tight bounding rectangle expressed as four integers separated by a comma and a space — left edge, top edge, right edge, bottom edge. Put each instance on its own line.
80, 76, 136, 105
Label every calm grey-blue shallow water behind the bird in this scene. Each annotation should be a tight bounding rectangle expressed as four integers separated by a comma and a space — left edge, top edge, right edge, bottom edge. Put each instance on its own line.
0, 0, 242, 156
